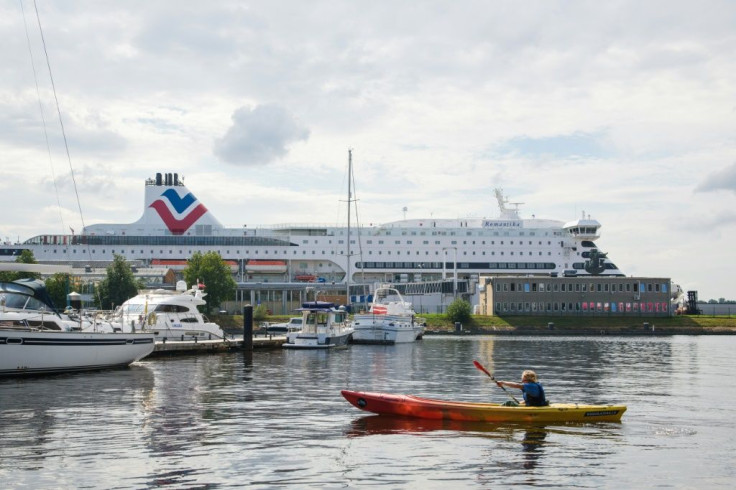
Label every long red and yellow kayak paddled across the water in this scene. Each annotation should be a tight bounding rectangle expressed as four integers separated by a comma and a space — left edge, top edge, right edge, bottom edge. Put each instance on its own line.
341, 390, 626, 423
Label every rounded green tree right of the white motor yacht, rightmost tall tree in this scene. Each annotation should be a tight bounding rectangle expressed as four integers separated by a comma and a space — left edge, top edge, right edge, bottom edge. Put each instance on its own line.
183, 252, 237, 313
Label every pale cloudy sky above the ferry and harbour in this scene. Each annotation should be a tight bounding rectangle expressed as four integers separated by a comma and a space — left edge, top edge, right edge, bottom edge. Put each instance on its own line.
0, 0, 736, 300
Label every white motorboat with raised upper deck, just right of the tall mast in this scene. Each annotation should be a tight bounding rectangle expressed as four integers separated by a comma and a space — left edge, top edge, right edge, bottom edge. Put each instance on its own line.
353, 286, 425, 344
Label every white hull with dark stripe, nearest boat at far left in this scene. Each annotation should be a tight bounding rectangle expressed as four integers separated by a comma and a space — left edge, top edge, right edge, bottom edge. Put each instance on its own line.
0, 330, 155, 376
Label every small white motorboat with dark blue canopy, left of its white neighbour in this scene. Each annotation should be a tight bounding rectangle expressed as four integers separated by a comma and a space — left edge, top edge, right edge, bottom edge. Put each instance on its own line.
283, 301, 353, 349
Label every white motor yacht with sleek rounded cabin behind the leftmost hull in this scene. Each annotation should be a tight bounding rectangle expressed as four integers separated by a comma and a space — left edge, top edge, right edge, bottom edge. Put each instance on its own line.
114, 281, 225, 341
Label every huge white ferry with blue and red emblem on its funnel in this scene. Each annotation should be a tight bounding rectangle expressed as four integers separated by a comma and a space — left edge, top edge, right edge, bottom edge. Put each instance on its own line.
0, 173, 623, 284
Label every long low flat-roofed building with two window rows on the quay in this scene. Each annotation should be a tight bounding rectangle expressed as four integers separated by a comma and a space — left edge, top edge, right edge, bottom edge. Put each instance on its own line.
478, 276, 673, 317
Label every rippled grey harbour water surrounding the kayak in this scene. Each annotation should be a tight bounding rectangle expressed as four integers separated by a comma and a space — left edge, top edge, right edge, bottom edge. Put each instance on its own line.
0, 337, 736, 488
